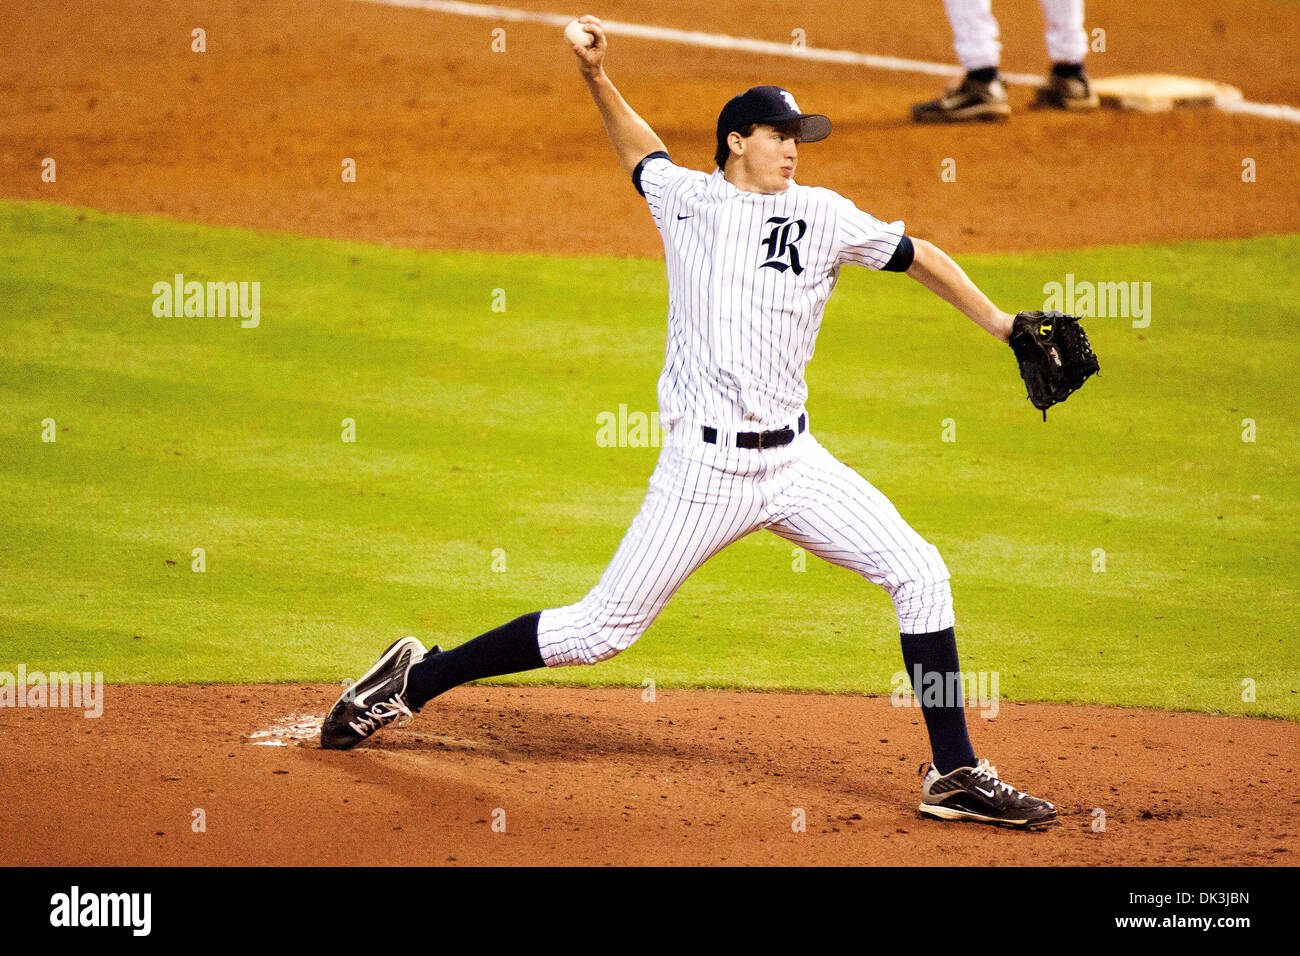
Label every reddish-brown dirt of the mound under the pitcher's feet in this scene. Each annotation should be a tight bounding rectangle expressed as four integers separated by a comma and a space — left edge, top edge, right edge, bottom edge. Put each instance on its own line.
0, 685, 1300, 866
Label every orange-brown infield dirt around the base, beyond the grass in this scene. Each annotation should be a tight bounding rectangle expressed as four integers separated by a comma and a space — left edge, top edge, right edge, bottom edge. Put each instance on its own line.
0, 0, 1300, 256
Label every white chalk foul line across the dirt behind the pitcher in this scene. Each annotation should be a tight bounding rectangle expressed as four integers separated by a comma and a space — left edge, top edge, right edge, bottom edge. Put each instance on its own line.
355, 0, 1300, 122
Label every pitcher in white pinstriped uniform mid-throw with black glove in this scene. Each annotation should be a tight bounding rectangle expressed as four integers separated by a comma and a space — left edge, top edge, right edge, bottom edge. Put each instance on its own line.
321, 17, 1096, 827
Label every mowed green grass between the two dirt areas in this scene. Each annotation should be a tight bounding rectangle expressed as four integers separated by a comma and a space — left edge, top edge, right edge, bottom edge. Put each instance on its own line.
0, 203, 1300, 719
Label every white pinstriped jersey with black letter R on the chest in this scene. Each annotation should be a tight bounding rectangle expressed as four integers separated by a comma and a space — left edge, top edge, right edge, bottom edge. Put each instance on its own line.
637, 155, 904, 431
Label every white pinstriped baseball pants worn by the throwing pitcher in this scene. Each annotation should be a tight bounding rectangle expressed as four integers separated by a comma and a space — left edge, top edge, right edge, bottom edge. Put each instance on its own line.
537, 424, 953, 667
